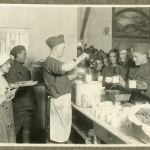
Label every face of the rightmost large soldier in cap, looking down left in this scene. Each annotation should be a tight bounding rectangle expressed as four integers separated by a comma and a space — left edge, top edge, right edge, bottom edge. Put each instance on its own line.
133, 52, 145, 66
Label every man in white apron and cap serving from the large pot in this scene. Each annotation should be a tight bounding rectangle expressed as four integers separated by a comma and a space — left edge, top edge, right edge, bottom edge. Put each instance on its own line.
43, 35, 88, 143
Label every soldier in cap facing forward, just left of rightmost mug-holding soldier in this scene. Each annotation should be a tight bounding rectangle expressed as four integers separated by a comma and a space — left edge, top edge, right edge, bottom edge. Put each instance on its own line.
115, 41, 134, 81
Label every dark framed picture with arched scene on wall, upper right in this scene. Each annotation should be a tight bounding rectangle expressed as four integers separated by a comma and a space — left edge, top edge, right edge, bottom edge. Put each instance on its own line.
112, 7, 150, 39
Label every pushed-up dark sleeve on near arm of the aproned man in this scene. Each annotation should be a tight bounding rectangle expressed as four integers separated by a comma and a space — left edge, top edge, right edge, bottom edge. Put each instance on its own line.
46, 60, 65, 75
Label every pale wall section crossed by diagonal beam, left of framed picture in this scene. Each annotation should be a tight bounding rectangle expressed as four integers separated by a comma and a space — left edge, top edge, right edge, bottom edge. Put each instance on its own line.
78, 7, 112, 52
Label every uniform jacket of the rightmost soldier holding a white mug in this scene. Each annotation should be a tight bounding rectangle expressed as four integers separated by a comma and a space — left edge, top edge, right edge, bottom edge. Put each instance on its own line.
125, 61, 150, 104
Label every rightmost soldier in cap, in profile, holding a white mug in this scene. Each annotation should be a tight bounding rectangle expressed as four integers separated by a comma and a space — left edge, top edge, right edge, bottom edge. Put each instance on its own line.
119, 43, 150, 104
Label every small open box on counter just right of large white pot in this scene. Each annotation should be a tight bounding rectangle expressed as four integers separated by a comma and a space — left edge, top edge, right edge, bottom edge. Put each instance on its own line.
107, 90, 131, 101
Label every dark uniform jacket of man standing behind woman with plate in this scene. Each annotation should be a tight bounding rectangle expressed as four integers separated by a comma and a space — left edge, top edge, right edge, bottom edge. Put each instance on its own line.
6, 60, 37, 112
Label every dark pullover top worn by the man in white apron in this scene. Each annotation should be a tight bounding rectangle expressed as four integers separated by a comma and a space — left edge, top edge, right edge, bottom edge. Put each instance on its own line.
43, 56, 71, 98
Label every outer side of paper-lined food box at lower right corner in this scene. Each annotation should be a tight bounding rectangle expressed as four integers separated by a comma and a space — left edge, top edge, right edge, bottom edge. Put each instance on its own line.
132, 123, 150, 144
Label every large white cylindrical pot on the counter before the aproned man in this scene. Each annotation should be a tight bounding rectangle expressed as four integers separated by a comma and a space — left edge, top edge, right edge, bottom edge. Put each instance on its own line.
75, 81, 104, 107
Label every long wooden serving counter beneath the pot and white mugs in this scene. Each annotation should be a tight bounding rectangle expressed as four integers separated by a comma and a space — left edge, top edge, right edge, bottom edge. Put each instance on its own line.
72, 95, 143, 144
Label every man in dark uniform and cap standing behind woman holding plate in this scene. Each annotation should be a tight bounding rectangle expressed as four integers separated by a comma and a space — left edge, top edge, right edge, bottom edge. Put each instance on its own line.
6, 45, 37, 143
